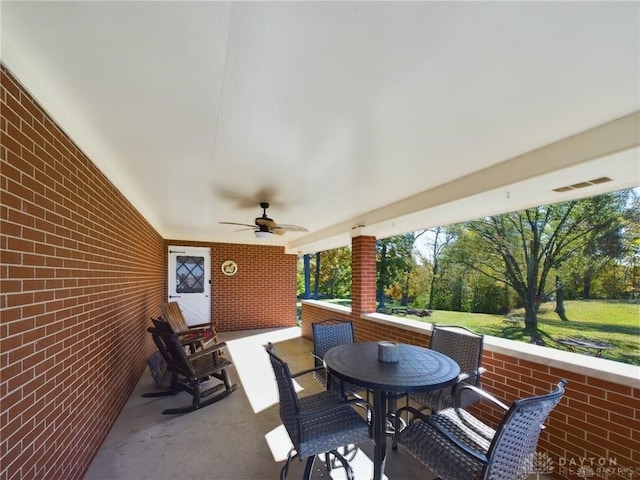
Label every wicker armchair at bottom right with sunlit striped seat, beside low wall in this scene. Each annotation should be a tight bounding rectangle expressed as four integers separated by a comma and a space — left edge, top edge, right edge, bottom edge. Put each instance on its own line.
393, 380, 567, 480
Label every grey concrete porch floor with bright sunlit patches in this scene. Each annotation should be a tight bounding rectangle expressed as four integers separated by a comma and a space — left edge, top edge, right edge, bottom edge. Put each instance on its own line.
84, 327, 548, 480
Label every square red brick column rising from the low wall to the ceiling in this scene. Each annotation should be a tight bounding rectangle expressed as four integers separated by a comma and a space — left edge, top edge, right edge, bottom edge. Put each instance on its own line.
351, 236, 376, 316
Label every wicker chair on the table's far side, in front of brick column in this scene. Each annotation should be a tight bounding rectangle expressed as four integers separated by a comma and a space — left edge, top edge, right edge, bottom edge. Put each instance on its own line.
311, 319, 368, 398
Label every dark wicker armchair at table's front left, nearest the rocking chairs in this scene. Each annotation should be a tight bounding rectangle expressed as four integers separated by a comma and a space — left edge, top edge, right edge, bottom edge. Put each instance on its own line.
265, 343, 373, 480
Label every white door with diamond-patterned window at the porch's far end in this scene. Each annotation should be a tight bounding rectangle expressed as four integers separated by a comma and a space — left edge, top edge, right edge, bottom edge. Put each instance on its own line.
169, 246, 211, 325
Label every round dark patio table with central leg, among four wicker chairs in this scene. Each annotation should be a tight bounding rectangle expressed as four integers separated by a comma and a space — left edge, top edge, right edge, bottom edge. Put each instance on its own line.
324, 342, 460, 480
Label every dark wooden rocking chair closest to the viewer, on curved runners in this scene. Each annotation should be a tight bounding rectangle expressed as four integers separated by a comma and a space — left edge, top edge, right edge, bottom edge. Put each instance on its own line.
143, 320, 238, 414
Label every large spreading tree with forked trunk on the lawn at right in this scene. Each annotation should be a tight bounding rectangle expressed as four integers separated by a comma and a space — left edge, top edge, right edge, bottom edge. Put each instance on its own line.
464, 190, 629, 327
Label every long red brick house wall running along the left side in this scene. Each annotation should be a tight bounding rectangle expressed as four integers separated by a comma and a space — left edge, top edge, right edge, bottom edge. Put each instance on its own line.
0, 67, 166, 480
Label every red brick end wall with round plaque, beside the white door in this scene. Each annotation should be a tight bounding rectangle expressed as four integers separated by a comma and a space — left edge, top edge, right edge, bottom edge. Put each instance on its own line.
165, 240, 297, 332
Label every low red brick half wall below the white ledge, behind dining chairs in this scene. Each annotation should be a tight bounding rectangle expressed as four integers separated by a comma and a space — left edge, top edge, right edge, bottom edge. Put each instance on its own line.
302, 302, 640, 480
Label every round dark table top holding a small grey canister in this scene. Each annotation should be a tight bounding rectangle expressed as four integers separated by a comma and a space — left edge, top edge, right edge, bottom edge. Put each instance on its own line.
324, 342, 460, 392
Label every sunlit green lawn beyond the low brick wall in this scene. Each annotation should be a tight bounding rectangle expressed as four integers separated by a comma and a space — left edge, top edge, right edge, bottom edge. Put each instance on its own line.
404, 300, 640, 365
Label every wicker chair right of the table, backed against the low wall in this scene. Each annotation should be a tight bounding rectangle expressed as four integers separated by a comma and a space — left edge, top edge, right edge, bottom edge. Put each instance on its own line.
409, 324, 485, 412
